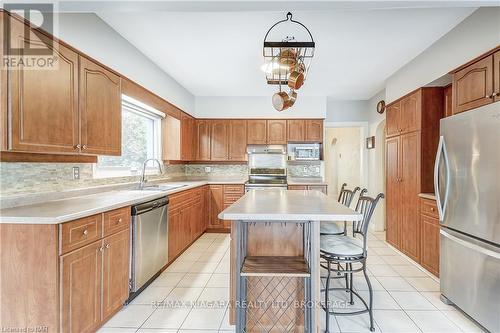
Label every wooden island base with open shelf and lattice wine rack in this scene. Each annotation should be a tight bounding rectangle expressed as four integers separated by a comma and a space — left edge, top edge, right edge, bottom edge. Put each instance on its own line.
230, 221, 319, 333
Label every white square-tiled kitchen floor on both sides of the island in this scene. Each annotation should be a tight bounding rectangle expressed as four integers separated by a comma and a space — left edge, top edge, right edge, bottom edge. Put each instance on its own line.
99, 233, 483, 333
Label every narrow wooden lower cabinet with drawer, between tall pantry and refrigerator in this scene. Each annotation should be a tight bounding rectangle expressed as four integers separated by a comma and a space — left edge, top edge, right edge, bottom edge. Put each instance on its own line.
420, 198, 440, 277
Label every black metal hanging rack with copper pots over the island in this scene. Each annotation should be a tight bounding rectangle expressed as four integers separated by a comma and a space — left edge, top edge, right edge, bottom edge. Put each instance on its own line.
261, 12, 315, 111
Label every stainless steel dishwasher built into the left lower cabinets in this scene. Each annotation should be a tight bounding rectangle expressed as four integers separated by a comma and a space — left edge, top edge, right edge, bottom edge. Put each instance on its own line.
128, 197, 168, 301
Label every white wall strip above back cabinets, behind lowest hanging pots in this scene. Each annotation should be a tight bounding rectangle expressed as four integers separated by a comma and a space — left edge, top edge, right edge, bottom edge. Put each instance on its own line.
196, 96, 326, 118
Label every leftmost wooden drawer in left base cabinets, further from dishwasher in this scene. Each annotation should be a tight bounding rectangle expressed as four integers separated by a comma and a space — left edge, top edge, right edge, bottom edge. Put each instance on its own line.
59, 214, 102, 254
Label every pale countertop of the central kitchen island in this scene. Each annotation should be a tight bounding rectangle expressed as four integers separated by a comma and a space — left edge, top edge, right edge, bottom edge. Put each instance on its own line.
219, 189, 362, 221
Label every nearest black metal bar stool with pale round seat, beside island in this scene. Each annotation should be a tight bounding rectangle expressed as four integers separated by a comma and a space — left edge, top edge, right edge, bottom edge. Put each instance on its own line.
320, 190, 384, 333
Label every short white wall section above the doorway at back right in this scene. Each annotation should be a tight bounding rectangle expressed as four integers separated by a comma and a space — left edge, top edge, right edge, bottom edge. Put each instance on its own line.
326, 98, 368, 123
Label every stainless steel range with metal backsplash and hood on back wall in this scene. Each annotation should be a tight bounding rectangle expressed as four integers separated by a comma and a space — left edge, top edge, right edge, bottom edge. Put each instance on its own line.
245, 145, 287, 192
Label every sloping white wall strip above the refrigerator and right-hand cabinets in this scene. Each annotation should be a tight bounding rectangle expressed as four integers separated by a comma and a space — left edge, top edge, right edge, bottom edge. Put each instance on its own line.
385, 7, 500, 103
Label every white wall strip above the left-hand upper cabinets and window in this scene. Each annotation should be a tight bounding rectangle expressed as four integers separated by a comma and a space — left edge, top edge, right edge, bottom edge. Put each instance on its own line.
58, 13, 195, 114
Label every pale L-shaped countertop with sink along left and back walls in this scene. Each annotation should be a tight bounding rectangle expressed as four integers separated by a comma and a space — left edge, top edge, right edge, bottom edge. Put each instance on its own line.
0, 179, 246, 224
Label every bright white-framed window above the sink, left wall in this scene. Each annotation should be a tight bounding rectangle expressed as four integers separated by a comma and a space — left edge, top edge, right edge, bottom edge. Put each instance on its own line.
94, 95, 165, 178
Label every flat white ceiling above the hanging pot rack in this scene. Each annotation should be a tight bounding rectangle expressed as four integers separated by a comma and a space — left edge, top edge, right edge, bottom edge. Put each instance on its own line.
98, 3, 474, 100
